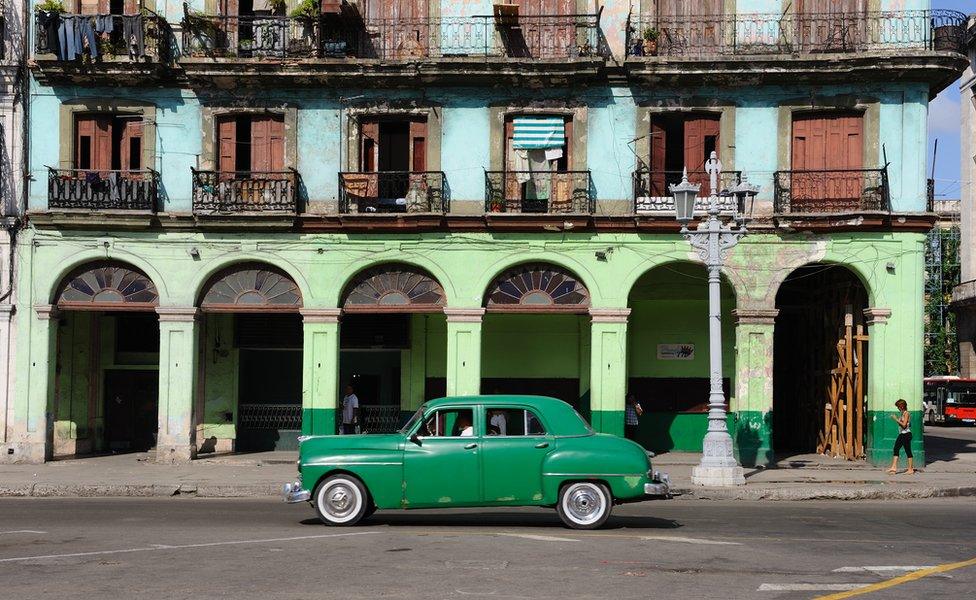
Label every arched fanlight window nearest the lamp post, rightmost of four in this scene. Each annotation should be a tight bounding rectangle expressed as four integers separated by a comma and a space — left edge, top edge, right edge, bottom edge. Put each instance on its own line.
485, 264, 590, 312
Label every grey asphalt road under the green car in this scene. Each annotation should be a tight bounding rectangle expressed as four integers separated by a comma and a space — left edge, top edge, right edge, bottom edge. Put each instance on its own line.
0, 498, 976, 600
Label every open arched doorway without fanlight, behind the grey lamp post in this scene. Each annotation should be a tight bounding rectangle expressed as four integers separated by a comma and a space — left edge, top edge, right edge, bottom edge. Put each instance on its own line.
627, 262, 735, 452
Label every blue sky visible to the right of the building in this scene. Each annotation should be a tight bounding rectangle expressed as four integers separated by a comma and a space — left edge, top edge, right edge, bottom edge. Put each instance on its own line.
926, 0, 976, 199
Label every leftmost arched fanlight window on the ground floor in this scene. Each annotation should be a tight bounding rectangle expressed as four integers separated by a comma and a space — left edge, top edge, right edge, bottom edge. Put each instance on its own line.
57, 262, 159, 310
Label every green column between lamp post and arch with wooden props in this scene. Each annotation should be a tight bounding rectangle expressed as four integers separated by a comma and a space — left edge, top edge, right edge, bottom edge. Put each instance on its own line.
729, 308, 779, 467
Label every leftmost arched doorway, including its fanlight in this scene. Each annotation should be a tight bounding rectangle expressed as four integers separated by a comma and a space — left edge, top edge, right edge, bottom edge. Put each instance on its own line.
51, 261, 159, 457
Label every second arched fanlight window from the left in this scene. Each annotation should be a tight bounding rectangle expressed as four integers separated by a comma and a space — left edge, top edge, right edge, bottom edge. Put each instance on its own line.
200, 264, 302, 312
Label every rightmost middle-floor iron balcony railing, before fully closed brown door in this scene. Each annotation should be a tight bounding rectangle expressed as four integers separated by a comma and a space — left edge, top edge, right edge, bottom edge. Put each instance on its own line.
773, 168, 891, 215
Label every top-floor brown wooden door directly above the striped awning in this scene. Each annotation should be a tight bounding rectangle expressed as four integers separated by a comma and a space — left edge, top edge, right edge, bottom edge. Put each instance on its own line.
506, 0, 576, 58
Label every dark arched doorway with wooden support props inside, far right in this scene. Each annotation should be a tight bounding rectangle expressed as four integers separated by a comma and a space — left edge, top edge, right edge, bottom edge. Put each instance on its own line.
773, 264, 868, 459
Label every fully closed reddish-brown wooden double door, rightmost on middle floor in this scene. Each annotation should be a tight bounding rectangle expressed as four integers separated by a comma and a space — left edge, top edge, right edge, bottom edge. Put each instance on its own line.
791, 114, 864, 212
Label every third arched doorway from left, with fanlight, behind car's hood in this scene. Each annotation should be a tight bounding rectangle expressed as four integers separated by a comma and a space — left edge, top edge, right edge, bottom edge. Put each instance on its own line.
339, 263, 447, 433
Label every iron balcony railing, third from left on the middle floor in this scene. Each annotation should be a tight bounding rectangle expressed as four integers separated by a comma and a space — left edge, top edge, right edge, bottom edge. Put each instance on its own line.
339, 171, 450, 214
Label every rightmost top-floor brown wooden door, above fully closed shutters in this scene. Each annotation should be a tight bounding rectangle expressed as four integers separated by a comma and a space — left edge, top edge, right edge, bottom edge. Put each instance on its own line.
796, 0, 866, 52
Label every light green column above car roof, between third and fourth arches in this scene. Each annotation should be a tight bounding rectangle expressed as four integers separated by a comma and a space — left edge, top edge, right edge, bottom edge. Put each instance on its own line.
444, 308, 485, 396
